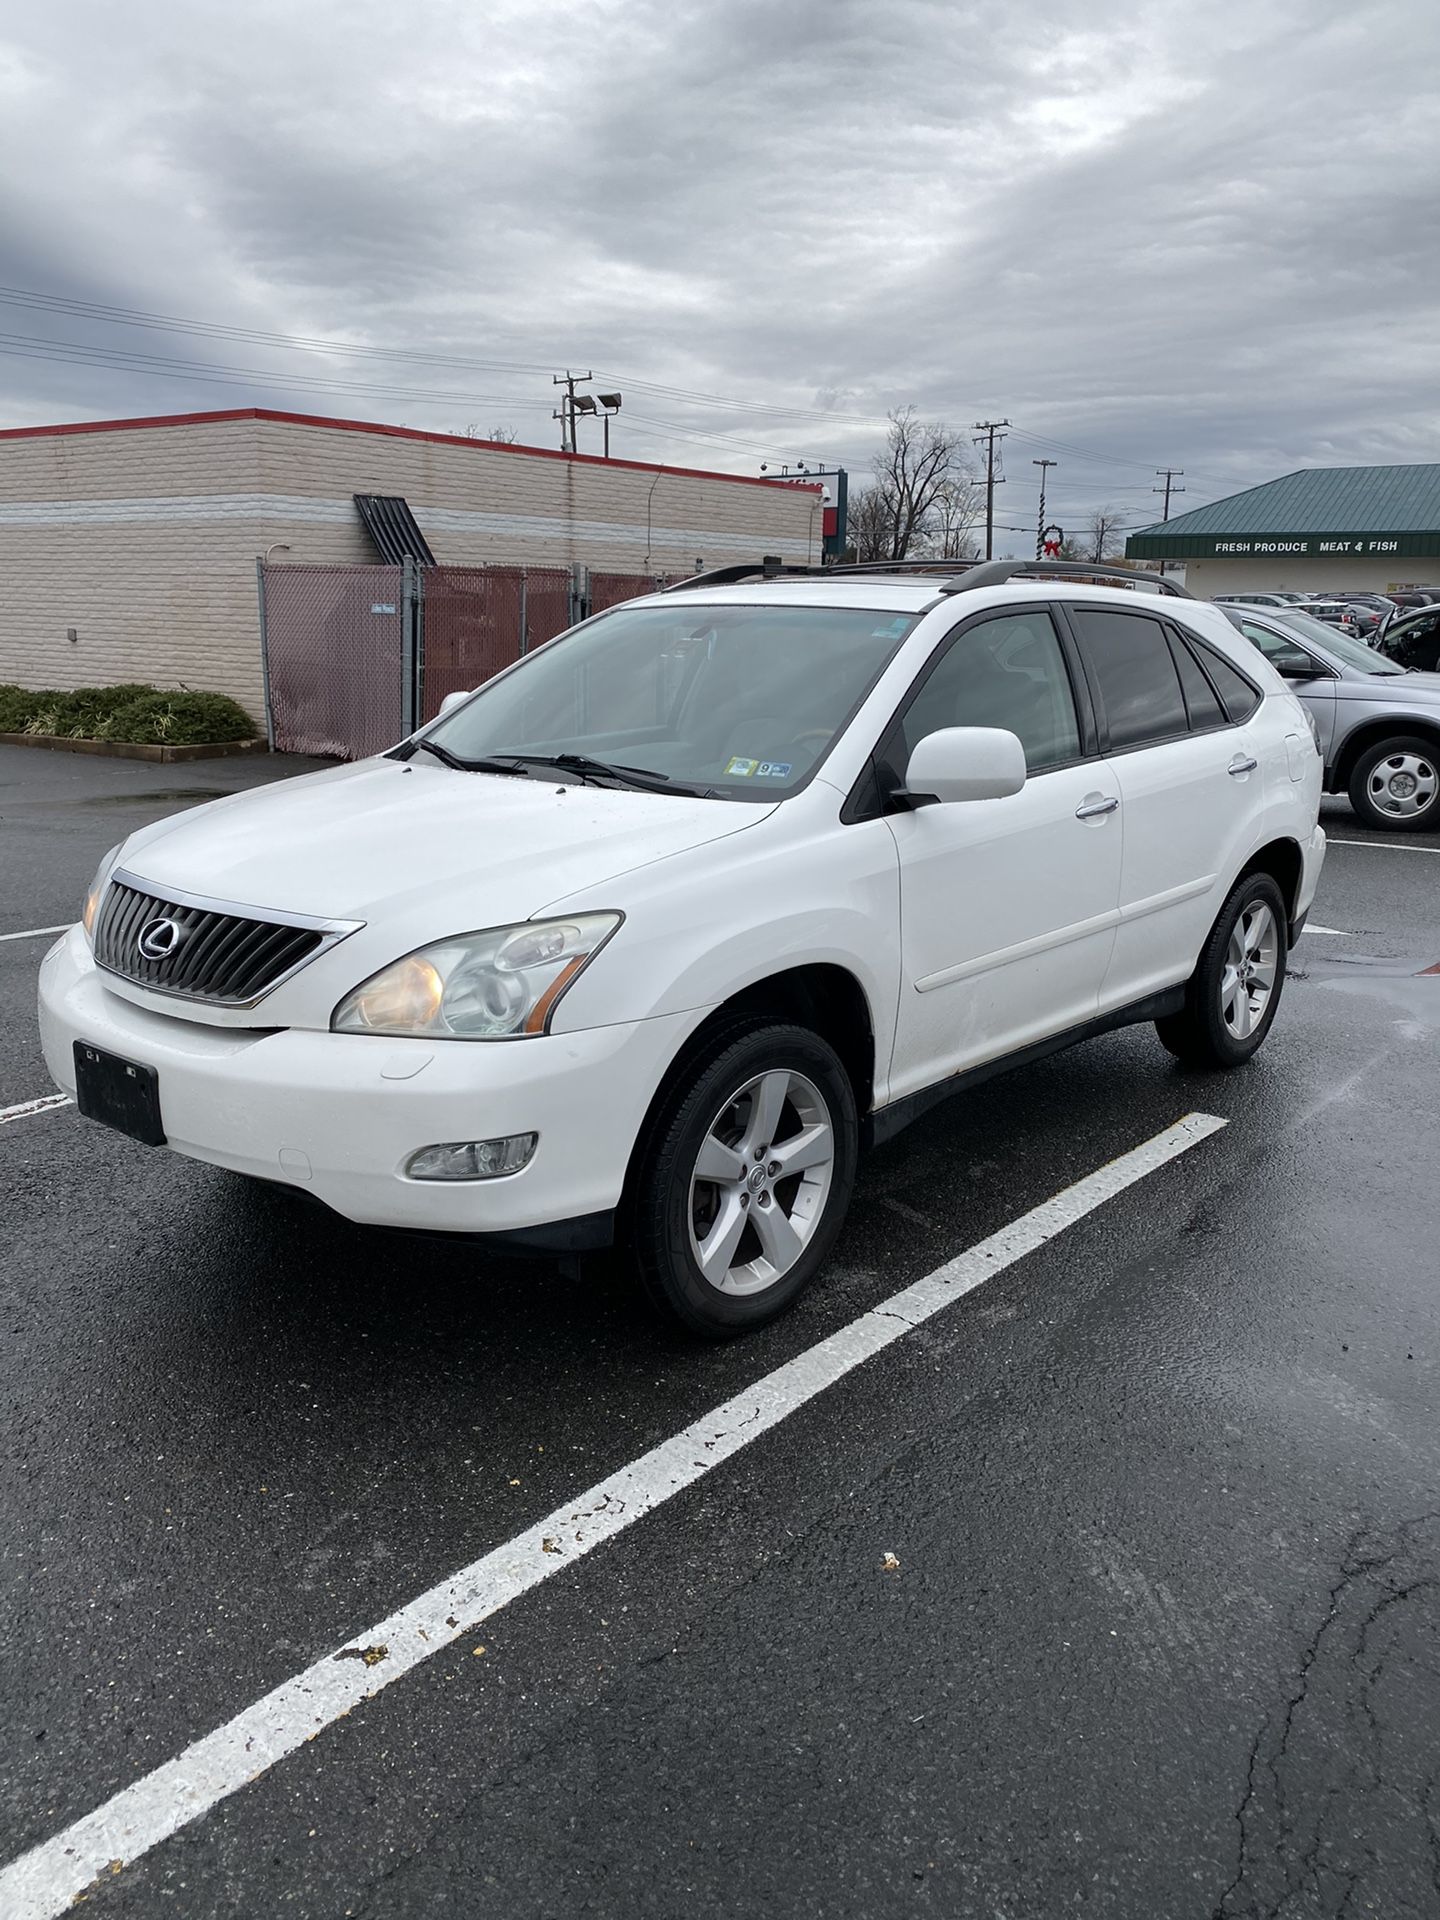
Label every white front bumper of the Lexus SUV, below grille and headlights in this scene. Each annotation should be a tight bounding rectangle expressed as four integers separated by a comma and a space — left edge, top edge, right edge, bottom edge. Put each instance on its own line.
40, 927, 705, 1236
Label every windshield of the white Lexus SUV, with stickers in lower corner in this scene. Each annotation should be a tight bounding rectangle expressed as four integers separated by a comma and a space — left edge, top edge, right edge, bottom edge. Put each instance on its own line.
414, 601, 920, 801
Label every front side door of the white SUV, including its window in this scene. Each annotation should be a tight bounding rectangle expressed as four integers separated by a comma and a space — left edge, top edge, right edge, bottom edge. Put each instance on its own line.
881, 607, 1121, 1098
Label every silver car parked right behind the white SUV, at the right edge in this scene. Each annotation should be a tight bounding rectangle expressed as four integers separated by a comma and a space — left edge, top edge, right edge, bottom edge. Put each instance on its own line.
1225, 607, 1440, 831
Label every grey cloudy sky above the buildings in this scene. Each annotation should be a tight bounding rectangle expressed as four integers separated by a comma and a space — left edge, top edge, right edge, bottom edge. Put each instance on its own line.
0, 0, 1440, 547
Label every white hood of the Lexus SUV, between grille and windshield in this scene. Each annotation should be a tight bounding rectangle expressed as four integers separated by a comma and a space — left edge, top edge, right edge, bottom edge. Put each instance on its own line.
119, 758, 774, 931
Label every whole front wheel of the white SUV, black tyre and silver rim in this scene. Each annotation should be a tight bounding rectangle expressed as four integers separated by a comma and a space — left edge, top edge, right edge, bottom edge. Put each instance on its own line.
630, 1021, 858, 1340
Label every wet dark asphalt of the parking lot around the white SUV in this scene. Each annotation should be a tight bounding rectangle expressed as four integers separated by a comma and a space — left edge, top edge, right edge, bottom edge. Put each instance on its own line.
0, 747, 1440, 1920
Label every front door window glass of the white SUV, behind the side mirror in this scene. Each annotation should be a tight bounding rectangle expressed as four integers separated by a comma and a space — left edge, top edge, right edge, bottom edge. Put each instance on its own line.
900, 609, 1081, 774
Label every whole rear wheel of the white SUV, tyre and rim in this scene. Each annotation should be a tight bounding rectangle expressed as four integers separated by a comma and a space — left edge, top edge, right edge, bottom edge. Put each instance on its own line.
1156, 874, 1288, 1068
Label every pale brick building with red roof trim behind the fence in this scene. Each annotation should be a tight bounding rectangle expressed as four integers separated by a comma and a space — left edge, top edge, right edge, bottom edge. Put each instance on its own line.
0, 407, 824, 714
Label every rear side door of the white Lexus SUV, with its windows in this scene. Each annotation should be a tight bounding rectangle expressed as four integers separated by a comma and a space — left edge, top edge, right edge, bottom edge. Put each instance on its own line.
1068, 603, 1265, 1012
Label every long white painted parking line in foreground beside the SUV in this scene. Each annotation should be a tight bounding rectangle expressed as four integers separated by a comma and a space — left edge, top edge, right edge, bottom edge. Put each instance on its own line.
0, 1114, 1225, 1920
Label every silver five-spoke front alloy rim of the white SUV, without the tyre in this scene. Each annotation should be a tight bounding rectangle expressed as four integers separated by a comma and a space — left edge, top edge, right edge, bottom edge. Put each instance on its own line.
689, 1068, 835, 1296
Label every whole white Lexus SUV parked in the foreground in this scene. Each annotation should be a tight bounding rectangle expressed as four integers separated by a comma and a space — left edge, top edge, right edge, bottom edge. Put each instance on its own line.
40, 563, 1325, 1334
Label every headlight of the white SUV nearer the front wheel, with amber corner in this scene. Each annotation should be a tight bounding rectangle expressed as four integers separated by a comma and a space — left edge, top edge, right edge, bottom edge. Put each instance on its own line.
330, 914, 624, 1041
